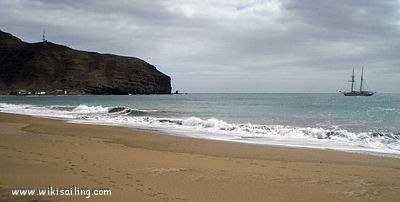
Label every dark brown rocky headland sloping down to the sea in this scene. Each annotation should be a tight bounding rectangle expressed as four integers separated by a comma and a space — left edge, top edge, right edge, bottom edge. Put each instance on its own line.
0, 31, 171, 94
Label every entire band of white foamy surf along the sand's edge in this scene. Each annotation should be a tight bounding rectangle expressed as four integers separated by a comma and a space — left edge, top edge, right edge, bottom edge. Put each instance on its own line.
0, 103, 400, 158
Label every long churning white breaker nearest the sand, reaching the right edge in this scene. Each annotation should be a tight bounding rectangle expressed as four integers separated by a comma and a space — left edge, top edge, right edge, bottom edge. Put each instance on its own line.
110, 116, 400, 155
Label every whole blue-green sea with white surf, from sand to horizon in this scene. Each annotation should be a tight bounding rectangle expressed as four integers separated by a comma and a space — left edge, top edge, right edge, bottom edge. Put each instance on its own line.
0, 94, 400, 158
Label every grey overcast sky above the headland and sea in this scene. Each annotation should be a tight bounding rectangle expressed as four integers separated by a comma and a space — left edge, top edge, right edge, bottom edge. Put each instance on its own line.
0, 0, 400, 93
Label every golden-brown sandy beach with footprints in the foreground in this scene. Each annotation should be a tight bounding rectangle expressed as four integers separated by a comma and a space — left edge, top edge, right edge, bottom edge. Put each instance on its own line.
0, 113, 400, 201
